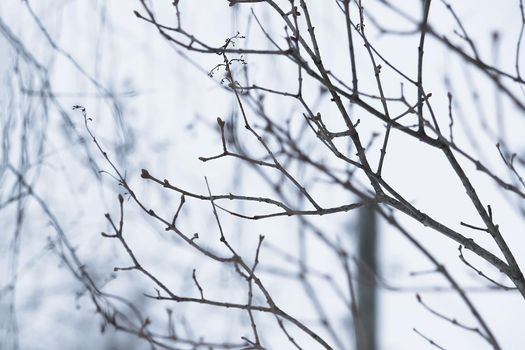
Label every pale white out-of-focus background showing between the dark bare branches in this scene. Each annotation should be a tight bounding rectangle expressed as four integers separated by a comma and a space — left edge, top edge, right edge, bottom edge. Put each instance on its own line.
0, 0, 525, 349
